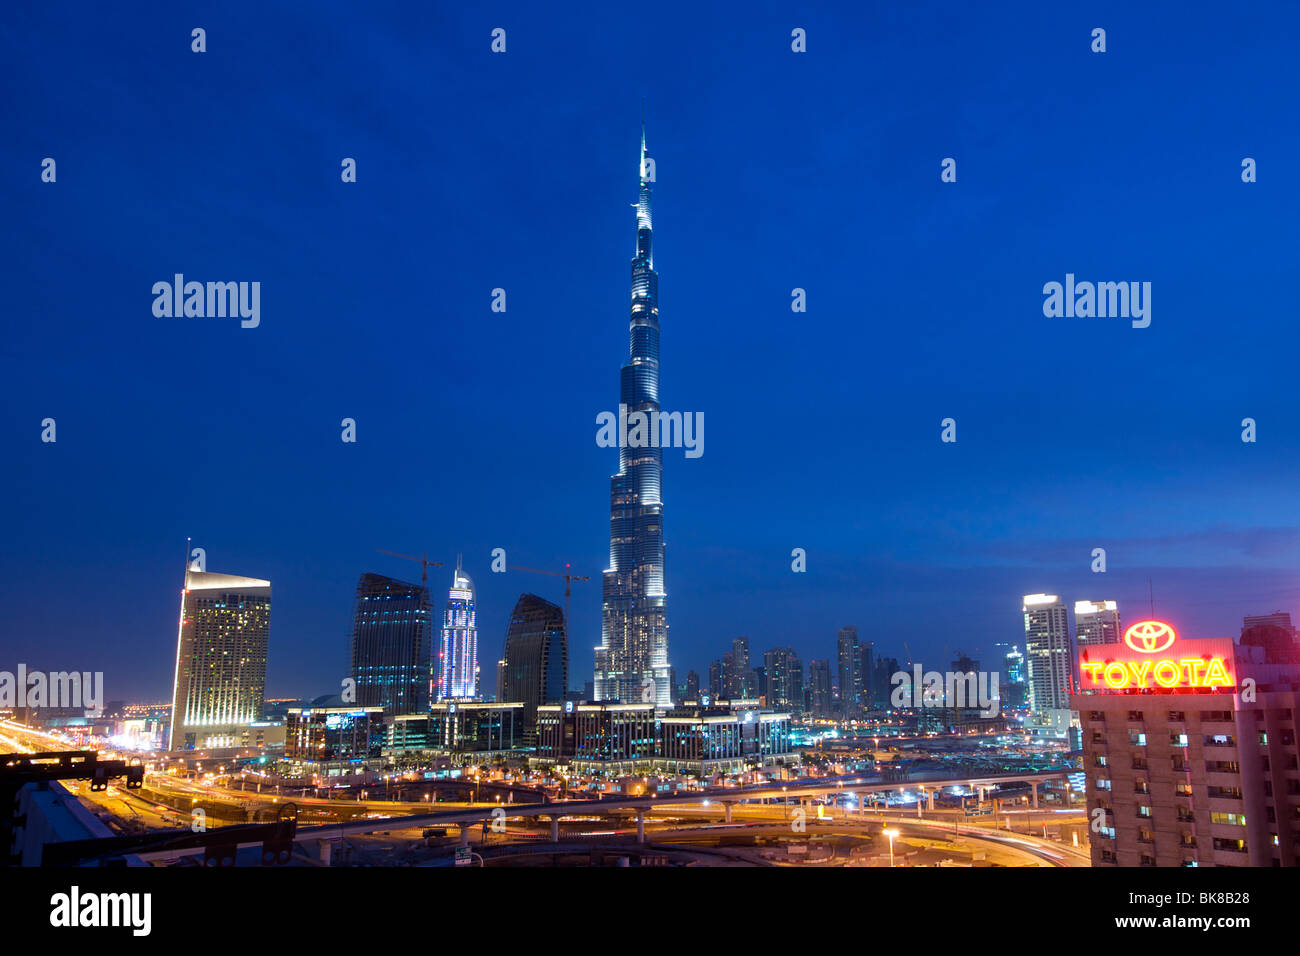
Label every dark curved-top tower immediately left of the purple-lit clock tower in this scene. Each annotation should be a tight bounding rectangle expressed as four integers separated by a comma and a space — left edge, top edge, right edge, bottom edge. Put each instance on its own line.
348, 572, 433, 717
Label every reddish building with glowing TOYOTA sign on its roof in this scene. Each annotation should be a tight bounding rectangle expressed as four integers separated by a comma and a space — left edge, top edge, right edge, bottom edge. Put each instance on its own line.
1071, 622, 1300, 866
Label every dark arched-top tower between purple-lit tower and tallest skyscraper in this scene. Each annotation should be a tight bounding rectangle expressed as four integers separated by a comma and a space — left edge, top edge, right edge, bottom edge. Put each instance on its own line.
499, 594, 568, 744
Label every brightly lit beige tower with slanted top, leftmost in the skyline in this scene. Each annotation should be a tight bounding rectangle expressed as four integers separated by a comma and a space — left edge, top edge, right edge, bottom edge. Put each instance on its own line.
168, 567, 270, 750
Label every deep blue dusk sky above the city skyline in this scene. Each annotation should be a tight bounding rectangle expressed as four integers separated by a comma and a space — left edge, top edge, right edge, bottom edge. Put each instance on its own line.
0, 3, 1300, 700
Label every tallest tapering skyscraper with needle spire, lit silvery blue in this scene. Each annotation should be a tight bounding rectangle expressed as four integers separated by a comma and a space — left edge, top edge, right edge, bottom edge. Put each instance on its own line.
594, 111, 672, 708
